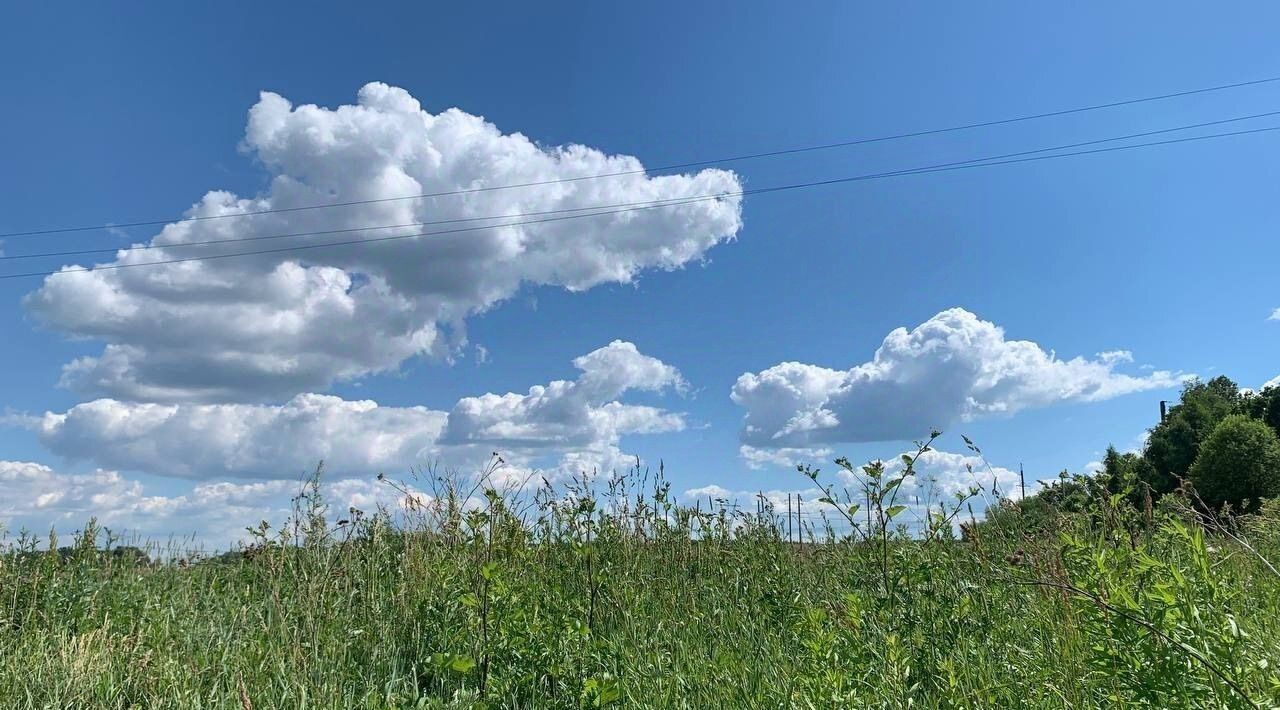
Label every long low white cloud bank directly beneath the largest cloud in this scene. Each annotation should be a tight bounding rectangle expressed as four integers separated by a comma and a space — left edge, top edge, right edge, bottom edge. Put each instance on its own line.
22, 340, 685, 480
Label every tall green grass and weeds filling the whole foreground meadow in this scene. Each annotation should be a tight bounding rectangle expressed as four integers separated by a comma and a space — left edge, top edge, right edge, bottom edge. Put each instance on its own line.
0, 457, 1280, 710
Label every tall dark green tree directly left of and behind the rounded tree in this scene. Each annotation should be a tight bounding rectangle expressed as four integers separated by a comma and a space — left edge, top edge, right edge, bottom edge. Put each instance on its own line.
1143, 376, 1242, 494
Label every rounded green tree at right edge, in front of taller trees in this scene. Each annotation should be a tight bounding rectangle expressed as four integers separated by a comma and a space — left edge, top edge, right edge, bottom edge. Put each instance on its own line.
1190, 414, 1280, 507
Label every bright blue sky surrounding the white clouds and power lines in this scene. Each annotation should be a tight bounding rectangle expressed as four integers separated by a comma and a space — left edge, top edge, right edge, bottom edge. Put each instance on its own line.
0, 3, 1280, 537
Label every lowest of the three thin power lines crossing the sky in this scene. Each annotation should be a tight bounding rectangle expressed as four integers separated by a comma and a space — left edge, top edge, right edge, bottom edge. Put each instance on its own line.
0, 125, 1280, 280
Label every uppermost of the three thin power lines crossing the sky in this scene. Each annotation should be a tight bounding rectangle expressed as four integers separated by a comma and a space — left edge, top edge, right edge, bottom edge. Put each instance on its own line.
0, 77, 1280, 239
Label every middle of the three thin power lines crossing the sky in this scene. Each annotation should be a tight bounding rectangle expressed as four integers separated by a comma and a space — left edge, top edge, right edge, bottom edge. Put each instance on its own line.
0, 111, 1280, 261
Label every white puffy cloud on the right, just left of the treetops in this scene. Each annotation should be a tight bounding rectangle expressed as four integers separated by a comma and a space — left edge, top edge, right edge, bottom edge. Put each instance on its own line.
732, 308, 1179, 450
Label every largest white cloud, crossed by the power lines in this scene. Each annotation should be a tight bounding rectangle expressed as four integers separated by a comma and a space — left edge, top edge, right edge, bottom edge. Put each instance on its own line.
26, 83, 741, 402
